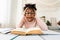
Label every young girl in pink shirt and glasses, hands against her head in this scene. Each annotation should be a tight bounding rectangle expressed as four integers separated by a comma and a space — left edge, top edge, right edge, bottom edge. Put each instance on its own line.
18, 4, 48, 30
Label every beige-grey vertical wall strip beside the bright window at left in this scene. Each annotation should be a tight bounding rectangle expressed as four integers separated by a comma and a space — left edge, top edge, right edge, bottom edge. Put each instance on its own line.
9, 0, 18, 27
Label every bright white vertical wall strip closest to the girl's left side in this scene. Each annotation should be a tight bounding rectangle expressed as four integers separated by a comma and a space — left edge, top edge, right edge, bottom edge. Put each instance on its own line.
16, 0, 23, 27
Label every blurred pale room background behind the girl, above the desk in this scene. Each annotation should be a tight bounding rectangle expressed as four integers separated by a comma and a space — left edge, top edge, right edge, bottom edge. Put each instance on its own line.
0, 0, 60, 29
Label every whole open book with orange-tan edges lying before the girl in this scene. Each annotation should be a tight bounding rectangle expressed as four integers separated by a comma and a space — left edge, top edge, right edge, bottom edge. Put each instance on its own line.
11, 28, 43, 34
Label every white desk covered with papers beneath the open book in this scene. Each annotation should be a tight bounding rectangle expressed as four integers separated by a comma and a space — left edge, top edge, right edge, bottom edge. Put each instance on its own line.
0, 30, 60, 40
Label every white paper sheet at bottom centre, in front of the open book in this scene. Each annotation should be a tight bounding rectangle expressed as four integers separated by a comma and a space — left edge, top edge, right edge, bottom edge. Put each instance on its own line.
14, 35, 43, 40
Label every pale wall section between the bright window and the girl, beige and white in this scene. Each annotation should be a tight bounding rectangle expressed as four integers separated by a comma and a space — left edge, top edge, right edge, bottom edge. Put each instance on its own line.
9, 0, 22, 28
